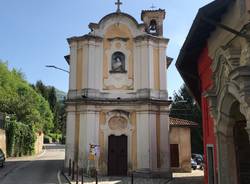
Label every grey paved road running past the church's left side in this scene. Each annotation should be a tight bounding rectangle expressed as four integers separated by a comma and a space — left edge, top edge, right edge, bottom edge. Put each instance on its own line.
0, 145, 66, 184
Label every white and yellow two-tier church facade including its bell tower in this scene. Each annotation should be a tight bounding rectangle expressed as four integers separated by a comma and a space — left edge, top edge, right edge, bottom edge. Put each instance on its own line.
65, 6, 170, 176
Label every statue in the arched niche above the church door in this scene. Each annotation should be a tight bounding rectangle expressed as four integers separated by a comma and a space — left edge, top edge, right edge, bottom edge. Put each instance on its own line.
110, 52, 126, 73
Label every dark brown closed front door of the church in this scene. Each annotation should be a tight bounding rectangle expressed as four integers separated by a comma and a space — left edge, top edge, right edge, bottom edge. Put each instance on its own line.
108, 135, 128, 176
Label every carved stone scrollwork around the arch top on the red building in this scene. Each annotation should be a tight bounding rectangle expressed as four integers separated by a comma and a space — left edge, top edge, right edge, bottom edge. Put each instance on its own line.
205, 42, 250, 139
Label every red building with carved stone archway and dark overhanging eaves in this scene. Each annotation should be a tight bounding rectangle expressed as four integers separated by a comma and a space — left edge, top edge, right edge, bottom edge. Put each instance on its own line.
176, 0, 250, 184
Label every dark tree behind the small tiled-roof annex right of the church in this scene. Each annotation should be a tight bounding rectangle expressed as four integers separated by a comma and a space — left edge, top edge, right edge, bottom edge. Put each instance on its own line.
170, 85, 203, 153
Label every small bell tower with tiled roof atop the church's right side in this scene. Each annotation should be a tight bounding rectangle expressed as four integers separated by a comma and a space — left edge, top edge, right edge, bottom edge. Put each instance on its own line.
141, 9, 166, 37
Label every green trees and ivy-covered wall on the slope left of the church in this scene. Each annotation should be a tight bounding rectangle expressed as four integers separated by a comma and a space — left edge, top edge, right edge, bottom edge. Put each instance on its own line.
0, 61, 64, 156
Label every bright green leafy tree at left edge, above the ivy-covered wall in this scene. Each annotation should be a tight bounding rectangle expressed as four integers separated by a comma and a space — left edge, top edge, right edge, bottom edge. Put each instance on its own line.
0, 61, 53, 132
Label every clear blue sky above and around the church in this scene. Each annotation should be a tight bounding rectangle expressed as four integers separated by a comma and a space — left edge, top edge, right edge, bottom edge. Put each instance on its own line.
0, 0, 212, 96
